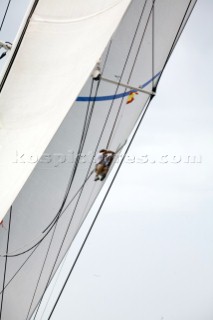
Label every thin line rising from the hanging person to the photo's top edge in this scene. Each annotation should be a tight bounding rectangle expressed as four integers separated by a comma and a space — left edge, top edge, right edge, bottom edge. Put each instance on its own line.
106, 0, 155, 148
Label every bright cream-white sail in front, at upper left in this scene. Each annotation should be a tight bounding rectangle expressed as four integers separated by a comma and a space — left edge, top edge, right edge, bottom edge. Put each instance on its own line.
0, 0, 130, 217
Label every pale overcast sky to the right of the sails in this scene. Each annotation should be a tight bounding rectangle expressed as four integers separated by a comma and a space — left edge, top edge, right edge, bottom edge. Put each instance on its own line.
0, 0, 213, 320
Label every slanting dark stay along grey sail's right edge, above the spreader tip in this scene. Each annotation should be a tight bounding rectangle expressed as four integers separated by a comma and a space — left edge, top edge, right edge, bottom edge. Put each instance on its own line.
156, 0, 197, 87
